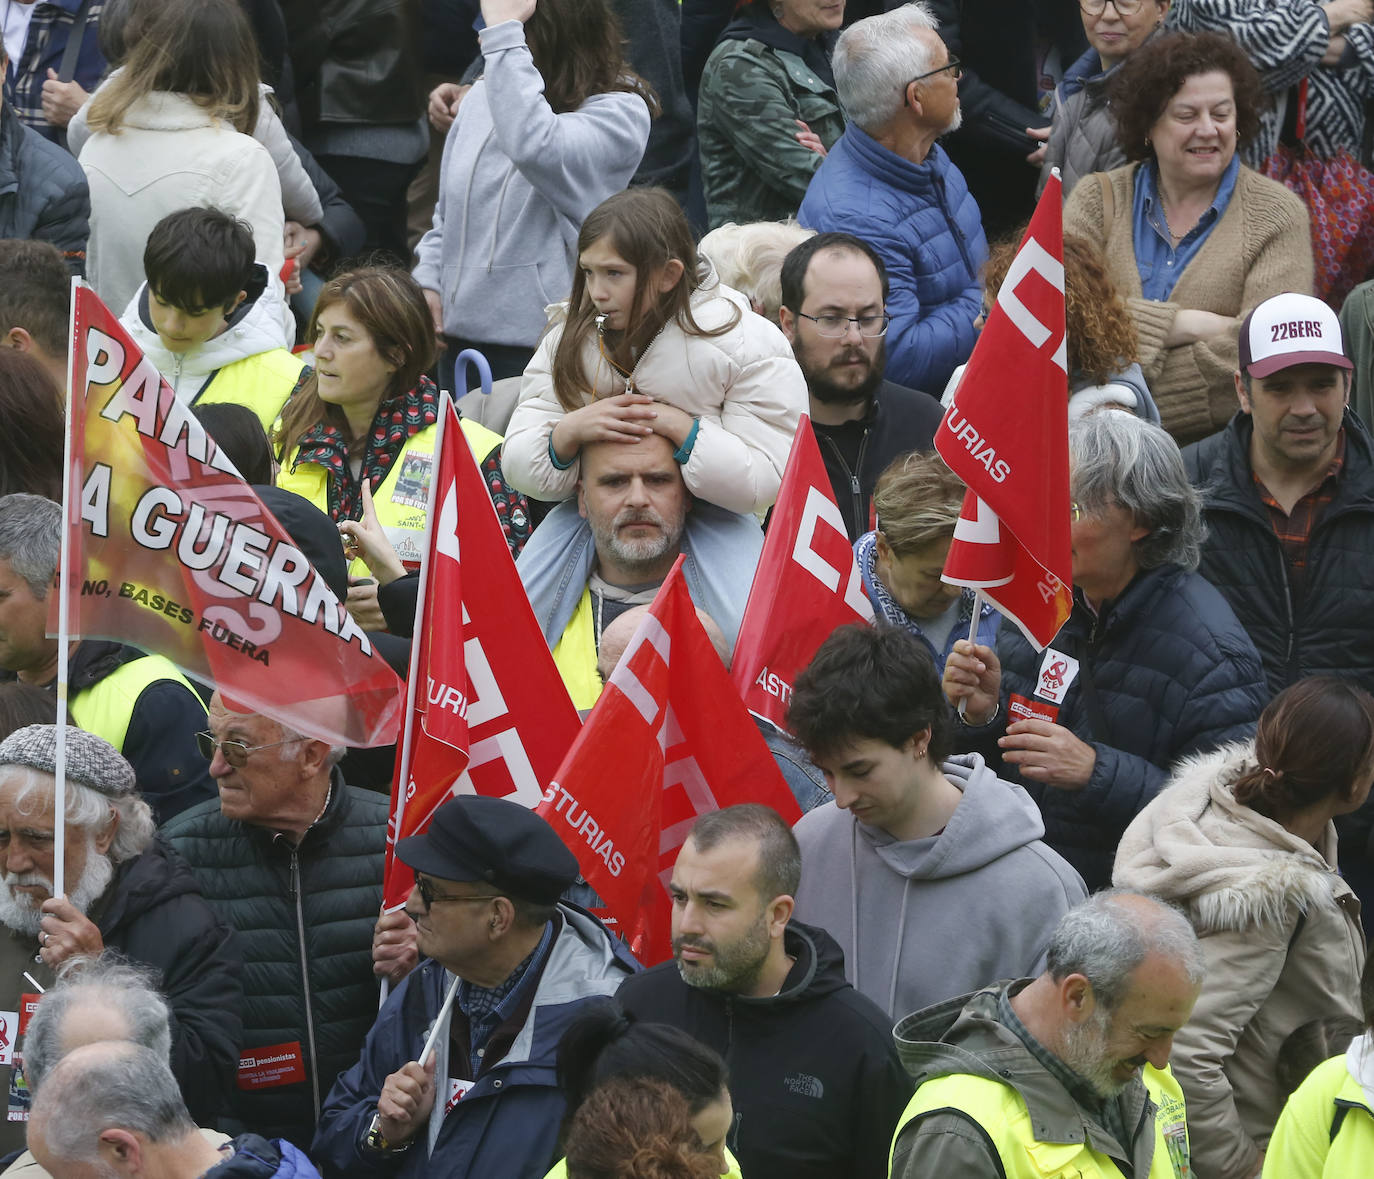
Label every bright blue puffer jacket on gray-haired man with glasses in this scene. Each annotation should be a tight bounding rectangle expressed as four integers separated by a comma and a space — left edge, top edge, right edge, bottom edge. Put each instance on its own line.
797, 124, 988, 392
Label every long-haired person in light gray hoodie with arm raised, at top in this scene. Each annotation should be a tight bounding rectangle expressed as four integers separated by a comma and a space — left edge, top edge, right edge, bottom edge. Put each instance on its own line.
415, 0, 658, 388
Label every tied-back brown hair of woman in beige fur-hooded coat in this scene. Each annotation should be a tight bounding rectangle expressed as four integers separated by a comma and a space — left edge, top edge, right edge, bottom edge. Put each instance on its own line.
1232, 676, 1374, 823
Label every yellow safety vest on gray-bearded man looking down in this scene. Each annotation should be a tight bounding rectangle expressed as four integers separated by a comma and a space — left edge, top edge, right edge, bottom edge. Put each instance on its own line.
888, 1065, 1193, 1179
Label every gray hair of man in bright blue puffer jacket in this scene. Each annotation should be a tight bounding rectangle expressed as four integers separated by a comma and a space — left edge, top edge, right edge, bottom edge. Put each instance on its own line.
831, 4, 940, 135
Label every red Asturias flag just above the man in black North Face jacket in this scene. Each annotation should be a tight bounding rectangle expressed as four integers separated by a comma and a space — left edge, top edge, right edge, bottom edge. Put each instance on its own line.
537, 558, 801, 965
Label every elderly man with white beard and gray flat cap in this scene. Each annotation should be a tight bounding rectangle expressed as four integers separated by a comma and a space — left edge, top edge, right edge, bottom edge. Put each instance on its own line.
0, 724, 242, 1153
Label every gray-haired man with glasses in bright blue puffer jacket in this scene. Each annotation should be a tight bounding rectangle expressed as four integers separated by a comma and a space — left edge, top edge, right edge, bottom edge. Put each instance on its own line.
797, 4, 983, 392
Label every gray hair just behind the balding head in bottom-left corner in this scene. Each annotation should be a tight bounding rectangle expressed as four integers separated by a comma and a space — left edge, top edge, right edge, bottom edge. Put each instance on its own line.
23, 951, 172, 1091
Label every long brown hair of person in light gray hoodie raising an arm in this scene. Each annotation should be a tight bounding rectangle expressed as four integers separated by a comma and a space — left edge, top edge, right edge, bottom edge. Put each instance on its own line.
525, 0, 660, 115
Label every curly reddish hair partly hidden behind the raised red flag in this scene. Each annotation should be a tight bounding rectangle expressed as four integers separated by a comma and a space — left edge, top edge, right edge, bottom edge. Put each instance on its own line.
982, 232, 1140, 385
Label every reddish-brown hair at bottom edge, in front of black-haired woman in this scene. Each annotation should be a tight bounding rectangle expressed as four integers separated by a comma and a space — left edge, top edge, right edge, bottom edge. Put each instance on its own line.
567, 1077, 720, 1179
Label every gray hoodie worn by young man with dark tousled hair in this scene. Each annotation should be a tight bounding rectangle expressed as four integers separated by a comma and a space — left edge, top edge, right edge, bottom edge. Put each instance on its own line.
793, 753, 1087, 1018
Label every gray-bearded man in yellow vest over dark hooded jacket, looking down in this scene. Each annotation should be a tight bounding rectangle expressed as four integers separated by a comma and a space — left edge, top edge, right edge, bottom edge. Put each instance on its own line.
892, 892, 1204, 1179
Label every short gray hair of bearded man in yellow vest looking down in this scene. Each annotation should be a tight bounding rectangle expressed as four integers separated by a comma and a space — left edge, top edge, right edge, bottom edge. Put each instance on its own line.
1046, 888, 1206, 1011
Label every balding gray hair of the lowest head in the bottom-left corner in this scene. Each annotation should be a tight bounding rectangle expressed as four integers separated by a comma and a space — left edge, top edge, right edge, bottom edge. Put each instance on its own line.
29, 1040, 195, 1163
